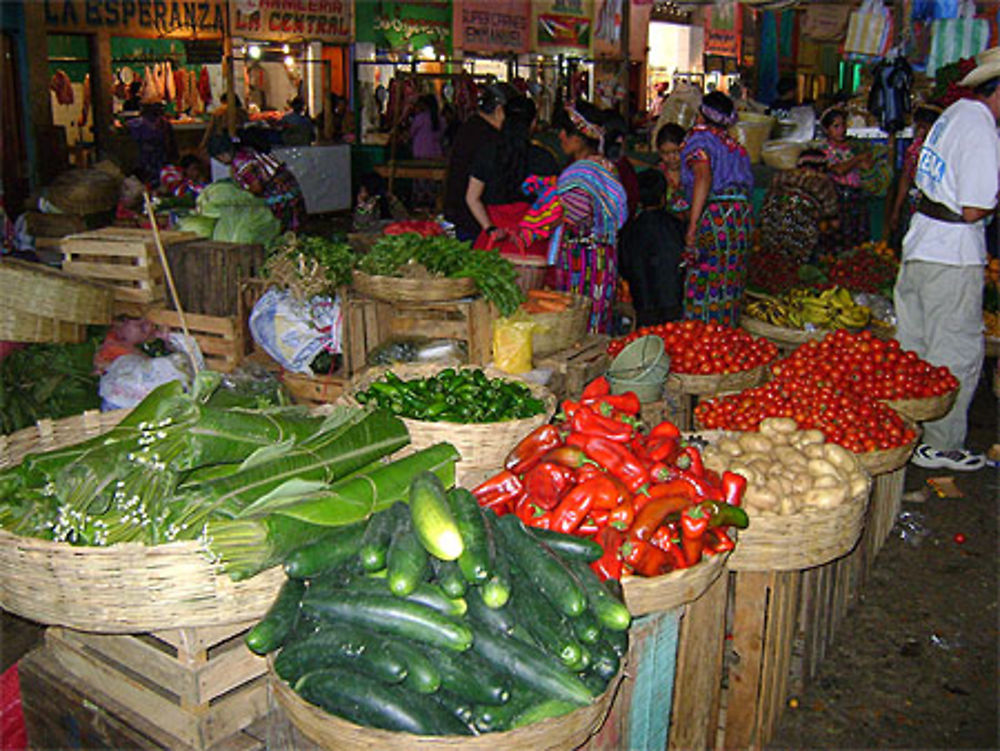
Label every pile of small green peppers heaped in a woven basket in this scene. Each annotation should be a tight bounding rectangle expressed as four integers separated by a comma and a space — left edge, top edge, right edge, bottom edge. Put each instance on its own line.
355, 368, 545, 423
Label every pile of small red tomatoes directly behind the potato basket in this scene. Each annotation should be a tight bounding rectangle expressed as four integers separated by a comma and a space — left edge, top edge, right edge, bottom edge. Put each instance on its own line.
695, 374, 916, 453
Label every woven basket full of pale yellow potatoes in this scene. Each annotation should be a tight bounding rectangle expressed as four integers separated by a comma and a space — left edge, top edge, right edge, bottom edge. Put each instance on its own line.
703, 418, 871, 571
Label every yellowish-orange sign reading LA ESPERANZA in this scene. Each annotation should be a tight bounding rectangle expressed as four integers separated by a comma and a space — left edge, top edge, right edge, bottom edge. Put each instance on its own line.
43, 0, 226, 37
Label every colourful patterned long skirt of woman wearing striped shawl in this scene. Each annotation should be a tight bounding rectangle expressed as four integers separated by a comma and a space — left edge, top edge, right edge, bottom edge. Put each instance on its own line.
555, 235, 618, 334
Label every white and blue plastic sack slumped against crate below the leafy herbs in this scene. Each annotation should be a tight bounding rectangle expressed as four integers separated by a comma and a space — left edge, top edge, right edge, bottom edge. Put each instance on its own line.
250, 287, 343, 376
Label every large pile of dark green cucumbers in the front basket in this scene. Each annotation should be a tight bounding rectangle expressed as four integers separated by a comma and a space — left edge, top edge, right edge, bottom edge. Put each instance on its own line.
246, 472, 630, 735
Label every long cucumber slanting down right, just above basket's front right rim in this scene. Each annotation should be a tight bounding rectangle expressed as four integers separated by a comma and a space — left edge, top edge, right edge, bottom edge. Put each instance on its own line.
472, 625, 593, 705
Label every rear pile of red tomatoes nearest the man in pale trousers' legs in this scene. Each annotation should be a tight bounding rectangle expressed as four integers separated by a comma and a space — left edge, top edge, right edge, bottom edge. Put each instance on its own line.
771, 330, 958, 399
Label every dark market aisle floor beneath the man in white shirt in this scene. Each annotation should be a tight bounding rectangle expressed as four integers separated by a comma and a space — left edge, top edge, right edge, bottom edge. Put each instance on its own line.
769, 368, 1000, 749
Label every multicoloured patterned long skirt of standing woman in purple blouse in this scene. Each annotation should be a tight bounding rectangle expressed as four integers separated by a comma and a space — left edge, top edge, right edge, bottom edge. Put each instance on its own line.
684, 197, 752, 326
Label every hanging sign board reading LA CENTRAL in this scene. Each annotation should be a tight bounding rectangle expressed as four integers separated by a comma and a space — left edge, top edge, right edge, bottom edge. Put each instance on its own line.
231, 0, 353, 43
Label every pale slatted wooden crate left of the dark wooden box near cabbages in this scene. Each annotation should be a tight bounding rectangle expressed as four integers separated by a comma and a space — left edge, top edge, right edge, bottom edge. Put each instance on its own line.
60, 227, 197, 304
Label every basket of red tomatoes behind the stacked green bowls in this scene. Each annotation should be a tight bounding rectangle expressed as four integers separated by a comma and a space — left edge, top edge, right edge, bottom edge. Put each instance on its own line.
608, 321, 778, 394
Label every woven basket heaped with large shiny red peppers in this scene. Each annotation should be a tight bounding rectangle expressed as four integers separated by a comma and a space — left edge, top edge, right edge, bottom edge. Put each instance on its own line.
473, 377, 748, 614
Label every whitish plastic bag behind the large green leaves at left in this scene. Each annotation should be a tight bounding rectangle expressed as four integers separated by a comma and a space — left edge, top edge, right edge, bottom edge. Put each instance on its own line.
98, 333, 205, 410
